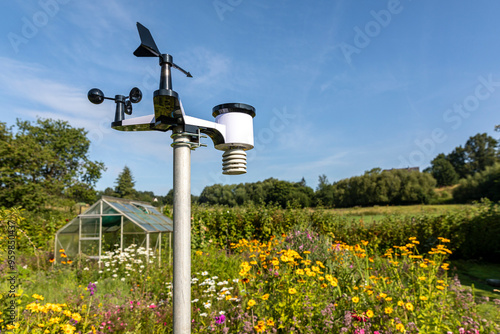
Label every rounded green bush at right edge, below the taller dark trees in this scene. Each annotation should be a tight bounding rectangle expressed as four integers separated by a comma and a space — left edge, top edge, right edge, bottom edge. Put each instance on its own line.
453, 163, 500, 203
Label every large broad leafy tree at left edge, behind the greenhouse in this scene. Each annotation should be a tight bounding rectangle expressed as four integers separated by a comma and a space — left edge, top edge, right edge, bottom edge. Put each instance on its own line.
0, 119, 105, 210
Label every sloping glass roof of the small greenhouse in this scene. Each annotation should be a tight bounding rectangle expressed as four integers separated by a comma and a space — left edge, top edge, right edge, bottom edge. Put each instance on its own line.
80, 196, 173, 233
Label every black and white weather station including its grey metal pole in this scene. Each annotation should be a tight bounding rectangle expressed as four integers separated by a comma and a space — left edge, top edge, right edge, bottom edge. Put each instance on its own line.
88, 23, 255, 334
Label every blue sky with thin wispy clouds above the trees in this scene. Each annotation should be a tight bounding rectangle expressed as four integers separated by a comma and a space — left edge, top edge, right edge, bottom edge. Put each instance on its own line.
0, 0, 500, 195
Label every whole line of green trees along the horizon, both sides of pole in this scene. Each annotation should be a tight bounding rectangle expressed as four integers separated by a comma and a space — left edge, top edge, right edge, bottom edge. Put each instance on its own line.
0, 119, 500, 210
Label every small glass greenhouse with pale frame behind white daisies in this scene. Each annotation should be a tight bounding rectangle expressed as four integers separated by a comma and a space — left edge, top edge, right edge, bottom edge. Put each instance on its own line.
54, 196, 173, 263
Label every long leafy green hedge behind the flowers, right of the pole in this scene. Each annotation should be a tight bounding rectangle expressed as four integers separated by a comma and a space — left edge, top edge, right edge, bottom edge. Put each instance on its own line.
192, 201, 500, 261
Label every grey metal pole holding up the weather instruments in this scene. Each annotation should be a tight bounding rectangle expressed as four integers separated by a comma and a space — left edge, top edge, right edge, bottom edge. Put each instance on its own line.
172, 127, 191, 334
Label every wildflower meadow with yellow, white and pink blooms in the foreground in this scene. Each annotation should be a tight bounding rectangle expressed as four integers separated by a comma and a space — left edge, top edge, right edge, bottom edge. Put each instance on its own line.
0, 204, 500, 334
